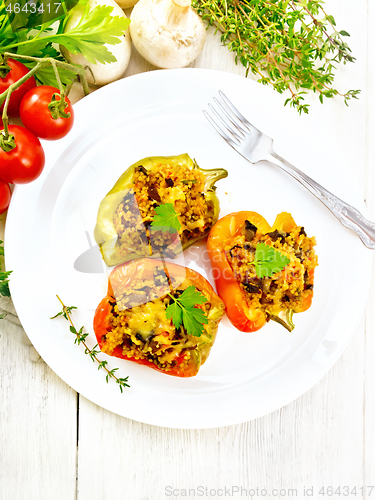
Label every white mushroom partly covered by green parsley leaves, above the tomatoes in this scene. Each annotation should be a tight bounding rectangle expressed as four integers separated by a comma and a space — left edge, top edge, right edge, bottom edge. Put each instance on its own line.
61, 0, 131, 85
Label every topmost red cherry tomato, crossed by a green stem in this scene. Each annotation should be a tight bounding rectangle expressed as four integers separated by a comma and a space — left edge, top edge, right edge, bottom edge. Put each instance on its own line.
0, 59, 36, 116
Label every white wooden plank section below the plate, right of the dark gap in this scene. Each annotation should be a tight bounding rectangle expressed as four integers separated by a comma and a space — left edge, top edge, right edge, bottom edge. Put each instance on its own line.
78, 330, 363, 500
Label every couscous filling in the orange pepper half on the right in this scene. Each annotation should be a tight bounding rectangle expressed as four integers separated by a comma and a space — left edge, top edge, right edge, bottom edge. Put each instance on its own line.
225, 221, 317, 318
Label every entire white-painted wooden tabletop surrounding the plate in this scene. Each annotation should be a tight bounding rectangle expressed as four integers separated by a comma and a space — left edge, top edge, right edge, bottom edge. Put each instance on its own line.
0, 0, 375, 500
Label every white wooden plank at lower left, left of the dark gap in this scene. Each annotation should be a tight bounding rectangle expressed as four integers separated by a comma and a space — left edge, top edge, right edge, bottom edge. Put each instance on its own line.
0, 320, 77, 500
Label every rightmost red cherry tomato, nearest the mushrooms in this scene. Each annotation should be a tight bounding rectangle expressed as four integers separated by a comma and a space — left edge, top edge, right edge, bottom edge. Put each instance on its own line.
20, 85, 74, 141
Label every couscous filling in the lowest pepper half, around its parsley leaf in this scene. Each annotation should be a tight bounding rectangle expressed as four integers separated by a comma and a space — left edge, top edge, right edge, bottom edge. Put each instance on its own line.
101, 267, 214, 371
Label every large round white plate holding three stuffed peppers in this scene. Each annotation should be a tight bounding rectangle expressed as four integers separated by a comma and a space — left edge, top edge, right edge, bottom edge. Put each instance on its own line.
5, 69, 371, 428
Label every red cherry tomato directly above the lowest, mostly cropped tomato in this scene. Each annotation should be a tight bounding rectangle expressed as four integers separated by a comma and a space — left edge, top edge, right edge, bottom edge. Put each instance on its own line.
0, 125, 45, 184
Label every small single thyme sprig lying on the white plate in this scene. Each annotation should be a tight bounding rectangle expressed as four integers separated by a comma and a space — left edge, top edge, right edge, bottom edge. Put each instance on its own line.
51, 295, 130, 392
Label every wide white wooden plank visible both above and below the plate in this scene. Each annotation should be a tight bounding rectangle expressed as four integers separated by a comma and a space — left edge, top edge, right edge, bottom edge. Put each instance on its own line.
78, 0, 375, 500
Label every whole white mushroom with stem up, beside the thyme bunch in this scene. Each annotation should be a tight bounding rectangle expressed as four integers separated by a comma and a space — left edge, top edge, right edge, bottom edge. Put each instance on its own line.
129, 0, 206, 68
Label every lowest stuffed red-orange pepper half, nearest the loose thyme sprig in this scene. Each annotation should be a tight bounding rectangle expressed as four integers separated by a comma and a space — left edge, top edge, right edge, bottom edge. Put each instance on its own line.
94, 259, 224, 377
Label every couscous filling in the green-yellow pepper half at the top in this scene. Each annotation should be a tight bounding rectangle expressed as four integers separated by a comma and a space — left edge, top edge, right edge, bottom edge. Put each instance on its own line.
113, 163, 214, 258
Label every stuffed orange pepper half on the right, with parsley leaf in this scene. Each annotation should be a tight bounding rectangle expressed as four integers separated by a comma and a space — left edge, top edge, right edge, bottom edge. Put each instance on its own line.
207, 211, 317, 332
